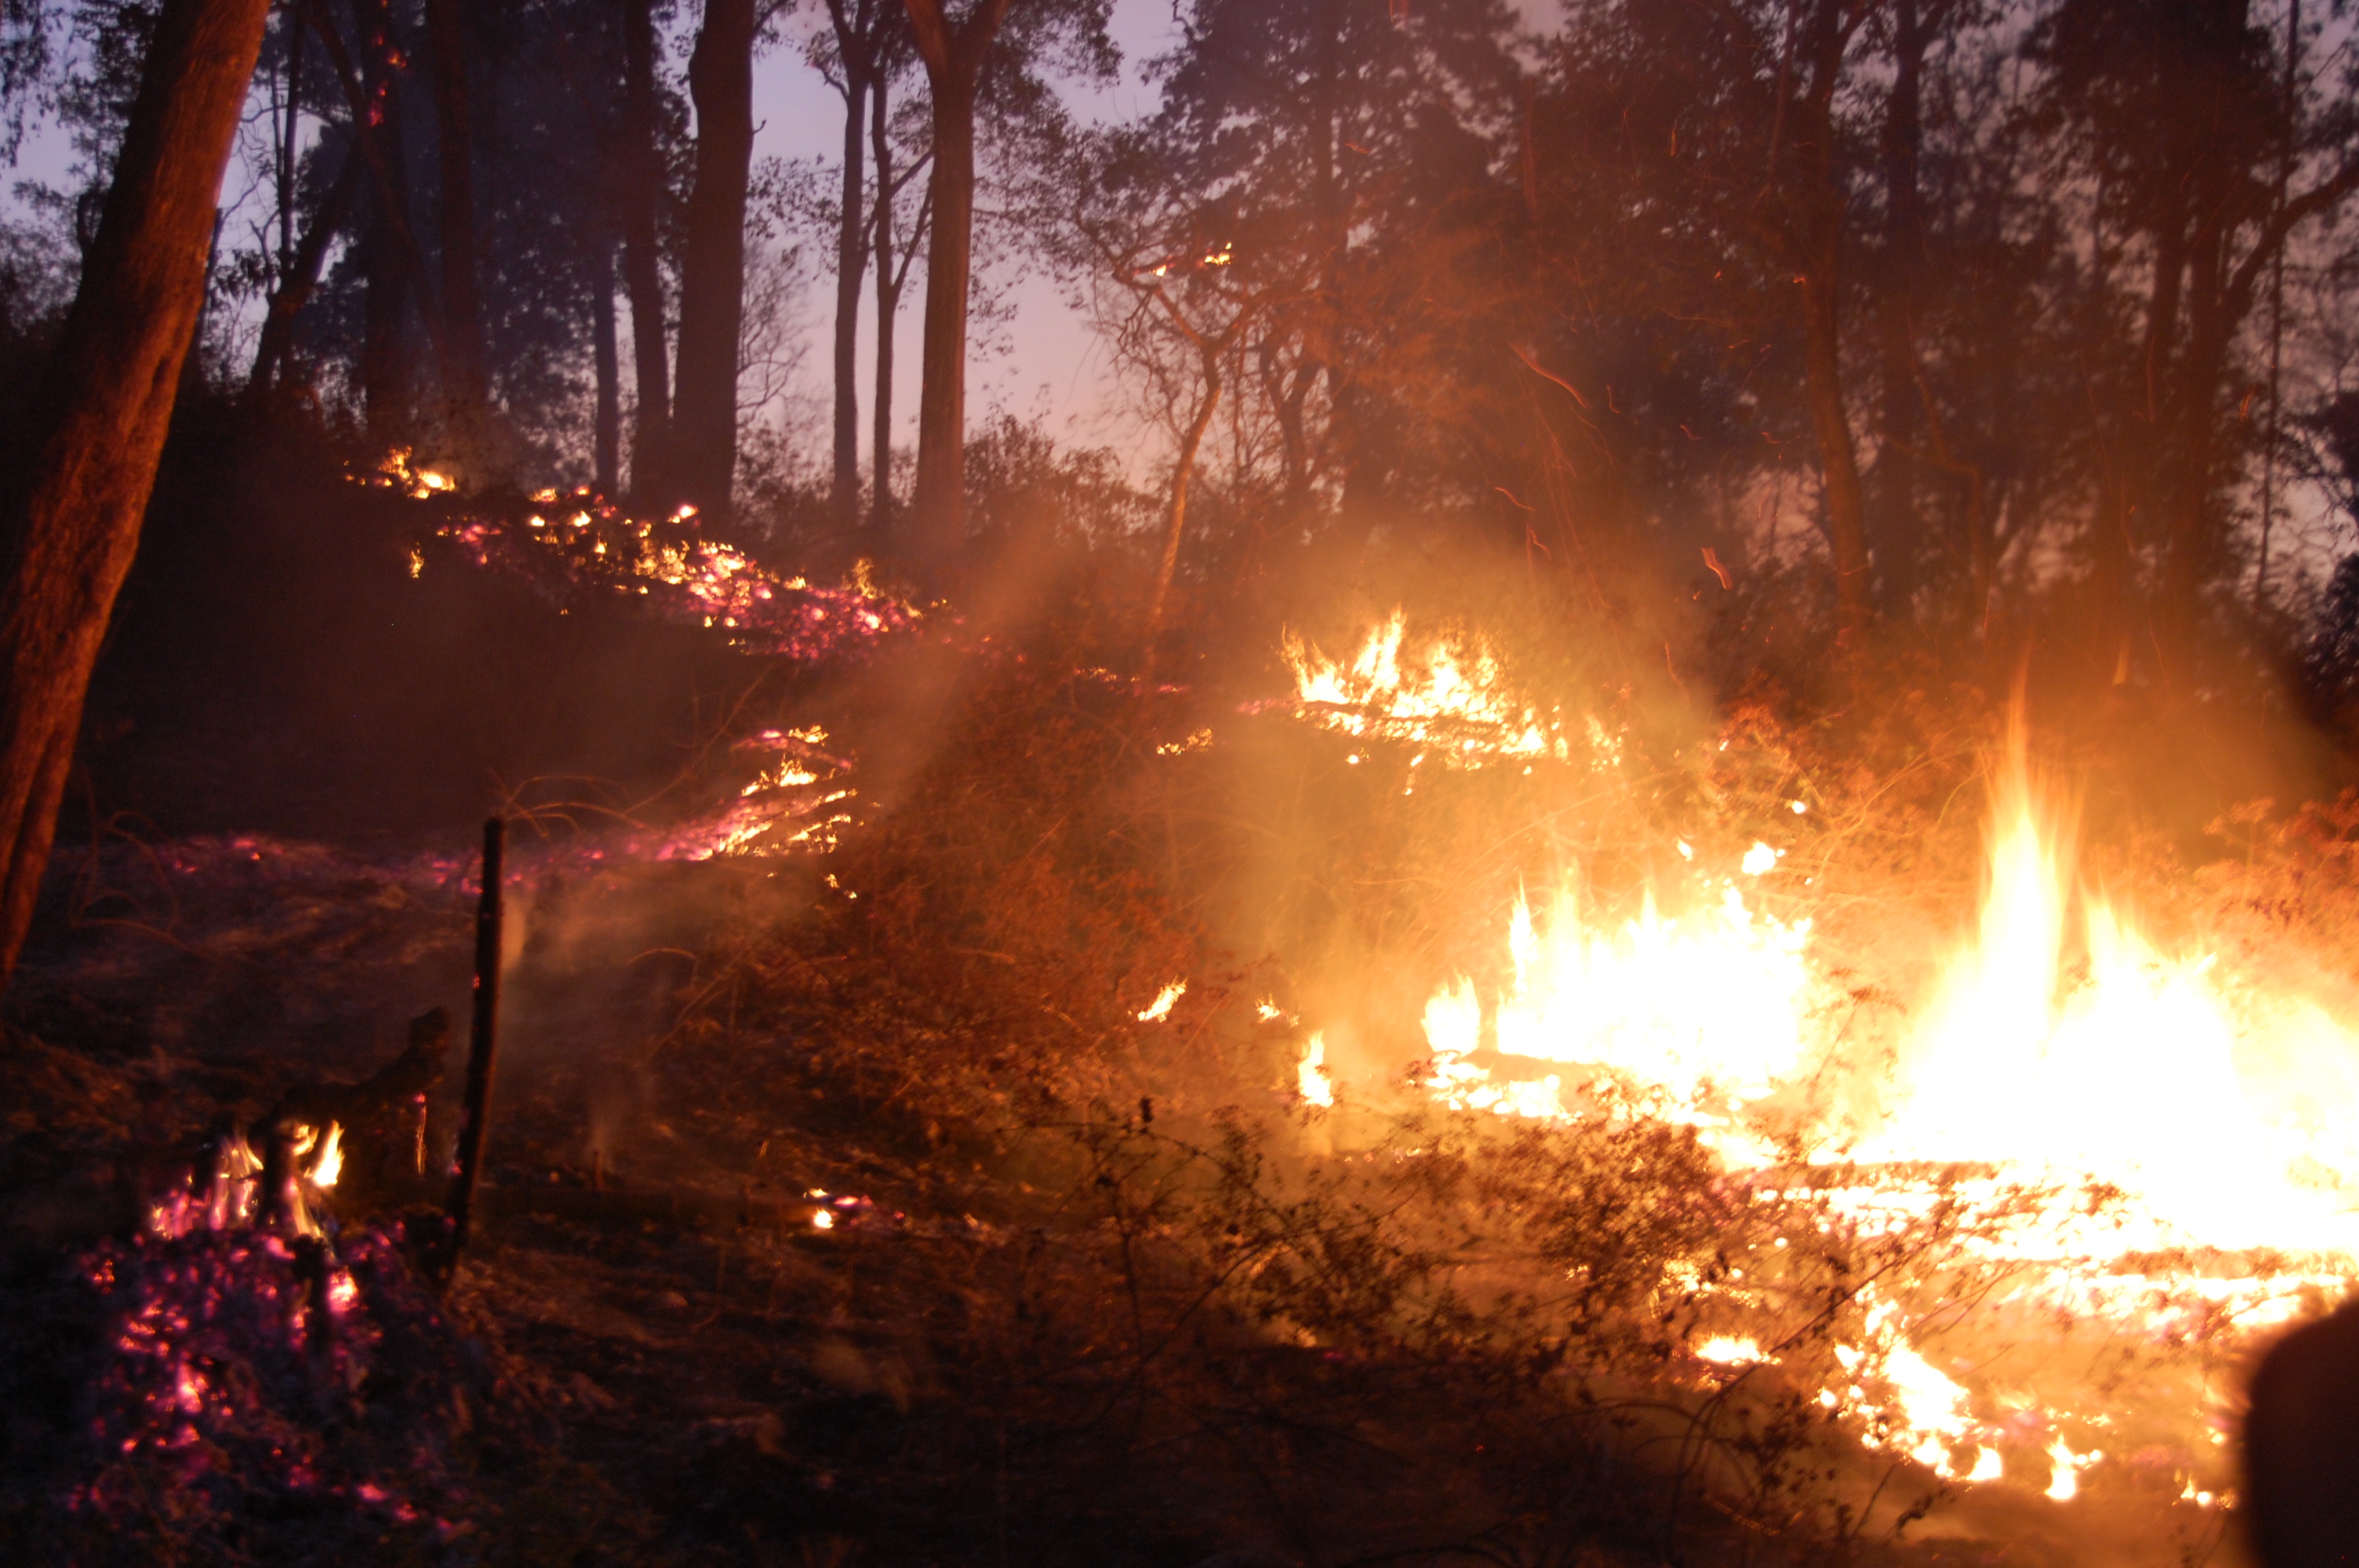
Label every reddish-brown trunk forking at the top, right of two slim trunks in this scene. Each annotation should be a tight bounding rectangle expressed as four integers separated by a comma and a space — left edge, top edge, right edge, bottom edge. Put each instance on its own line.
903, 0, 1007, 573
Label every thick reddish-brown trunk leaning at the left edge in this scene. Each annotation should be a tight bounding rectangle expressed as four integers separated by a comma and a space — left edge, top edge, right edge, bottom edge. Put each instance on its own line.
0, 0, 269, 976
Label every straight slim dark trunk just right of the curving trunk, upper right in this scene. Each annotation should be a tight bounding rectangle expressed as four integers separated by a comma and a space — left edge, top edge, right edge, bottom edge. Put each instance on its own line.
1875, 0, 1925, 620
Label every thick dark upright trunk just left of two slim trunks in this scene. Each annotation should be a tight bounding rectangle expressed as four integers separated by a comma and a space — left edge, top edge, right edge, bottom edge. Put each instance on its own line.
667, 0, 755, 521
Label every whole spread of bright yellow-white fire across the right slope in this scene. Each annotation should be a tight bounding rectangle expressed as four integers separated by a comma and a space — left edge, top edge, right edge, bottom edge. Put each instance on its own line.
1290, 618, 2359, 1504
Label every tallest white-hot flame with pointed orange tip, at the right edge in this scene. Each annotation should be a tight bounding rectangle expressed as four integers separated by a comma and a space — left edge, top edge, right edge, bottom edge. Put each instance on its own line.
1861, 731, 2359, 1252
